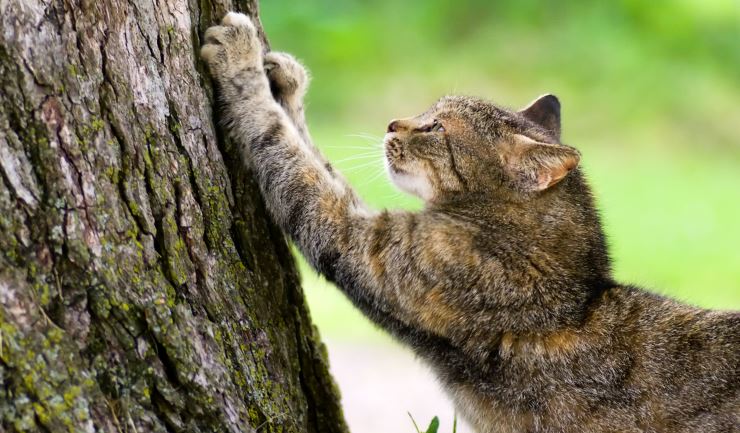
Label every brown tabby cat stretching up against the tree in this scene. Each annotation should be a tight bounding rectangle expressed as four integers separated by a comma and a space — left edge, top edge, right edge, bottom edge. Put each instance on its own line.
201, 13, 740, 433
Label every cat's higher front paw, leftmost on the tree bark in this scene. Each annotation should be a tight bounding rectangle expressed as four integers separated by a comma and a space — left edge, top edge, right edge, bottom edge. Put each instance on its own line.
200, 12, 263, 80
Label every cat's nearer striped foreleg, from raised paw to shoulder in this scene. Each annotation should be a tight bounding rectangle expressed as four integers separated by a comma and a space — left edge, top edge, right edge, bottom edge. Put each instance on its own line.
202, 13, 462, 340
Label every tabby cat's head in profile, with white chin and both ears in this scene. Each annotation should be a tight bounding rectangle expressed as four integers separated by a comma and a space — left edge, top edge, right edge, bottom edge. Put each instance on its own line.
385, 95, 580, 201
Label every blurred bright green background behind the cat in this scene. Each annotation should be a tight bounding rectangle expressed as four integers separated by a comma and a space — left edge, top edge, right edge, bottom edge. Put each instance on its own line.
261, 0, 740, 340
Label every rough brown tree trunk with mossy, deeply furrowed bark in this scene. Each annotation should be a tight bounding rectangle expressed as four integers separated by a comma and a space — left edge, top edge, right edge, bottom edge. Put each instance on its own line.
0, 0, 346, 433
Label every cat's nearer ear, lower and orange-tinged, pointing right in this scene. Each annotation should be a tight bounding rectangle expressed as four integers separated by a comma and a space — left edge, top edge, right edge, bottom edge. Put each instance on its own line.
501, 134, 581, 191
